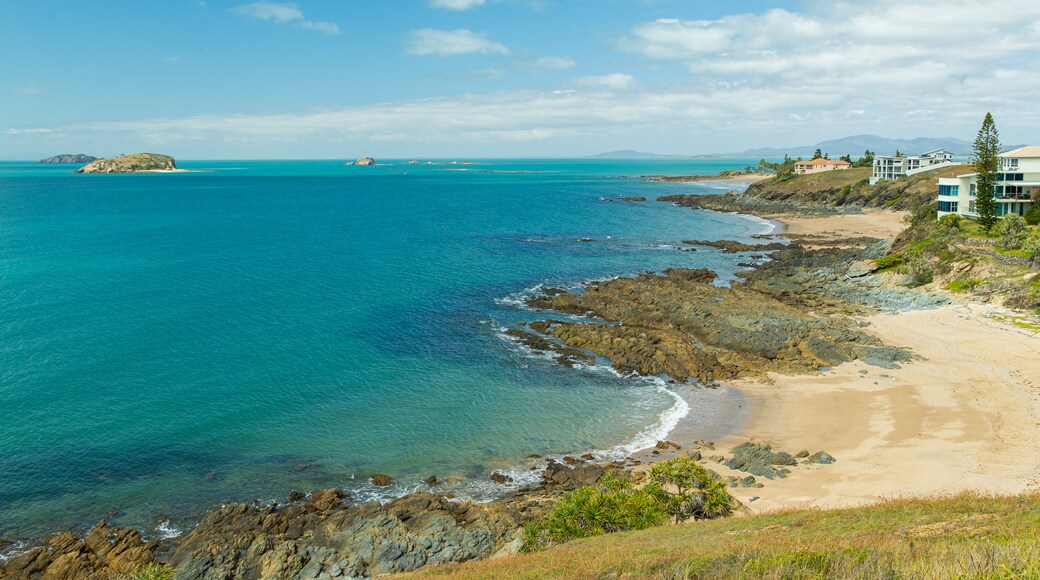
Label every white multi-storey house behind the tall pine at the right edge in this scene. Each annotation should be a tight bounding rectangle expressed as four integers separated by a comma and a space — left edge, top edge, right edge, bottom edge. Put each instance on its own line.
939, 146, 1040, 217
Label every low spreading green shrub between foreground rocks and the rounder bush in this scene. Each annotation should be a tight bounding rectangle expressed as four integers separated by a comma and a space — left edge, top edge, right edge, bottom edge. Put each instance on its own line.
521, 474, 668, 552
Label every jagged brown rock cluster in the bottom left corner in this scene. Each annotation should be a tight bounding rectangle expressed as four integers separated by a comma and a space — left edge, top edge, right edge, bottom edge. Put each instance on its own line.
0, 521, 157, 580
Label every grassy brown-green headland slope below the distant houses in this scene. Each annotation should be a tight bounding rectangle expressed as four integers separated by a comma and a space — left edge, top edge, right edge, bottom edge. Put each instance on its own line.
747, 164, 972, 210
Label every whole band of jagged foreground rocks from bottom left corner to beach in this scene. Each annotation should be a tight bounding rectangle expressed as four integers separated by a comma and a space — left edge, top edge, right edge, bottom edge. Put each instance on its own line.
0, 458, 618, 580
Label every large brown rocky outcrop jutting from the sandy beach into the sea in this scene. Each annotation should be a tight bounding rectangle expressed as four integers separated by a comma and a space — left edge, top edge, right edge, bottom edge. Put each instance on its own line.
528, 244, 910, 383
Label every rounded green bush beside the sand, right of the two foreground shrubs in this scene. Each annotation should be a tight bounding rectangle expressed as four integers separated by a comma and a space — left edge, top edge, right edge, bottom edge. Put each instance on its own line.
646, 456, 736, 524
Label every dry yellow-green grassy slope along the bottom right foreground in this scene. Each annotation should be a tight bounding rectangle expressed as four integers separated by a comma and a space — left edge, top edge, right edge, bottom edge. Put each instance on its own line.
407, 493, 1040, 578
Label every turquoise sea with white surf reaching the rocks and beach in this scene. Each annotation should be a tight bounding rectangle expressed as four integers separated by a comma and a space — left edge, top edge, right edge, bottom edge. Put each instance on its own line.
0, 159, 768, 539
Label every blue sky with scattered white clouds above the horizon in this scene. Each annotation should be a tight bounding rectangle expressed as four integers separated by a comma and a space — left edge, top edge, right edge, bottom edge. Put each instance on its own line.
0, 0, 1040, 159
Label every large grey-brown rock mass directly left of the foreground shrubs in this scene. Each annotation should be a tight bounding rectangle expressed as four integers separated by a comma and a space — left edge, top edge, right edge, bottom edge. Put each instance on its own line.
170, 493, 532, 580
